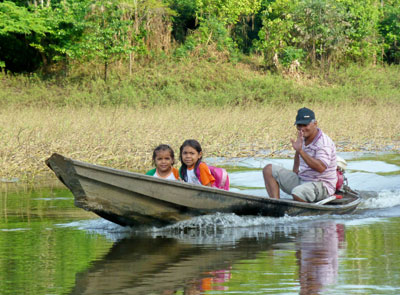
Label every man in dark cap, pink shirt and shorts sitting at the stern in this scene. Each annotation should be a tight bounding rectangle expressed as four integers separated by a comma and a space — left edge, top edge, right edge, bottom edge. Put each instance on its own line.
263, 108, 337, 202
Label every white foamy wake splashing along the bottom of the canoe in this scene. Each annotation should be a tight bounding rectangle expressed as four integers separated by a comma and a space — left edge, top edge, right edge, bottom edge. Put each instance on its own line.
58, 200, 400, 244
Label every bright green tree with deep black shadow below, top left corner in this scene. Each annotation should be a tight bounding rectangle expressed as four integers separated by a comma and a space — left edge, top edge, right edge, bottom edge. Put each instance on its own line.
0, 0, 89, 72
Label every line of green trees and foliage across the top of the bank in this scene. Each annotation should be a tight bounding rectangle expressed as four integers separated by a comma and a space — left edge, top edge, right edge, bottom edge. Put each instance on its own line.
0, 0, 400, 79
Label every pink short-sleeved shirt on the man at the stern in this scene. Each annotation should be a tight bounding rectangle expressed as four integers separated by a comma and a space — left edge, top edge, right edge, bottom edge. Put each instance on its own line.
298, 128, 337, 195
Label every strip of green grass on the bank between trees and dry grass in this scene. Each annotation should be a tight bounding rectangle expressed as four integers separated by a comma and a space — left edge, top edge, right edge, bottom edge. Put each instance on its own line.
0, 61, 400, 107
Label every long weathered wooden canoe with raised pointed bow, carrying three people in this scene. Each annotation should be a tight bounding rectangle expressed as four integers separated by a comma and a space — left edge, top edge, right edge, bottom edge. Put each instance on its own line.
46, 154, 361, 226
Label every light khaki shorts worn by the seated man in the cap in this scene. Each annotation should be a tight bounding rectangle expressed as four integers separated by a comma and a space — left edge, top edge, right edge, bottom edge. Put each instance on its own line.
272, 165, 329, 203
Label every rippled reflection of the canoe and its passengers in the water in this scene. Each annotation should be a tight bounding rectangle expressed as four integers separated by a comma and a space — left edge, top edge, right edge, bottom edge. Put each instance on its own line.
71, 220, 344, 295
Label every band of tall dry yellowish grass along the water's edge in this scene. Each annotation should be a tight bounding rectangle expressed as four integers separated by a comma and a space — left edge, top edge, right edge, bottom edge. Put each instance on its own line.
0, 104, 400, 180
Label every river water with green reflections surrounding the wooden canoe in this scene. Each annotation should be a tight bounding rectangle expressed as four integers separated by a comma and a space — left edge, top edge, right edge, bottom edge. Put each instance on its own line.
0, 153, 400, 295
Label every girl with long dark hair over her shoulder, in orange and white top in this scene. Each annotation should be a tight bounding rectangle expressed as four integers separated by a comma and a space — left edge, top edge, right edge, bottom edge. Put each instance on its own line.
179, 139, 215, 186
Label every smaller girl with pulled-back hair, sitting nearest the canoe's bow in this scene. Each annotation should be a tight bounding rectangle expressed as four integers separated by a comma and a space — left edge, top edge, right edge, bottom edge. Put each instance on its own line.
146, 144, 179, 180
